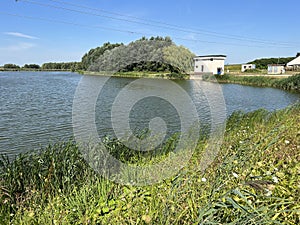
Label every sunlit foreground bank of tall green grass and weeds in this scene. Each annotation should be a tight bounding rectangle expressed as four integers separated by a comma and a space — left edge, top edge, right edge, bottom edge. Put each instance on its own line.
0, 105, 300, 225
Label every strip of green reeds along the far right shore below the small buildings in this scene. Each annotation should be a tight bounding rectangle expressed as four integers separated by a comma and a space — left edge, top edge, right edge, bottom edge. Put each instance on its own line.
203, 74, 300, 92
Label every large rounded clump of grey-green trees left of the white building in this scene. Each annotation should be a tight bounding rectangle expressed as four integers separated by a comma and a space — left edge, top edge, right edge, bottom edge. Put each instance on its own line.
82, 37, 194, 74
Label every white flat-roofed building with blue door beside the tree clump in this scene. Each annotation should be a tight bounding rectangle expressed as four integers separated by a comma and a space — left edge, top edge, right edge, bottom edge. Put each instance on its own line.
194, 55, 226, 75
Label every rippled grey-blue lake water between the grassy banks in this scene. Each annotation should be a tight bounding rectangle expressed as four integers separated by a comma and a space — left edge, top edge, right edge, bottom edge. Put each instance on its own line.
0, 72, 300, 156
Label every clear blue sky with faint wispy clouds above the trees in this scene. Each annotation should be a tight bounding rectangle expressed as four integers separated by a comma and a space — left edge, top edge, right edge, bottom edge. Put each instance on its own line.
0, 0, 300, 65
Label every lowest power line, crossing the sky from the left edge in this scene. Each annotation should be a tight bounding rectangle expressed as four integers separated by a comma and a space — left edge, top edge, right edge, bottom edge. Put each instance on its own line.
0, 11, 296, 48
